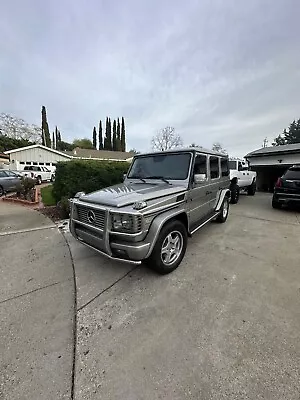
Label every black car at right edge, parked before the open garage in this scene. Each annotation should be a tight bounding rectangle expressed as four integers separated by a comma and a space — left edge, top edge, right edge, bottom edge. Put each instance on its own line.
272, 164, 300, 208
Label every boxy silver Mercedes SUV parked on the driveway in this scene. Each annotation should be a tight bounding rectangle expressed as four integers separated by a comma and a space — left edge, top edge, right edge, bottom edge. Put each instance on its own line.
70, 148, 230, 274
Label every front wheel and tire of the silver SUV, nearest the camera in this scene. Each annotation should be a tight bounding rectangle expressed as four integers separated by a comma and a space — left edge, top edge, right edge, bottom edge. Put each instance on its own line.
145, 220, 187, 275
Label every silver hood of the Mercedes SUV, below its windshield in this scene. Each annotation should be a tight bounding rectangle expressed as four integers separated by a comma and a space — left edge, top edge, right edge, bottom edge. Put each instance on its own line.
80, 183, 186, 207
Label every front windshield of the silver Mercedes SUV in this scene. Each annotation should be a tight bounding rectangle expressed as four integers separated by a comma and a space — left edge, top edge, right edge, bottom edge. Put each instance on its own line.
128, 153, 191, 180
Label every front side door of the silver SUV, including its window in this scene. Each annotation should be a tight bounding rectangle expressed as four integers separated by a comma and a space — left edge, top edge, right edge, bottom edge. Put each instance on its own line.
188, 154, 210, 231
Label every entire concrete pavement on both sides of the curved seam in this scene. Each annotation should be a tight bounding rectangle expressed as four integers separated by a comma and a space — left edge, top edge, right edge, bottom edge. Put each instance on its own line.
0, 194, 300, 400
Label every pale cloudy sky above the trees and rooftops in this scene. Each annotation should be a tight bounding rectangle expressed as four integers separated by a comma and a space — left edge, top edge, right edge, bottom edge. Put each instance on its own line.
0, 0, 300, 156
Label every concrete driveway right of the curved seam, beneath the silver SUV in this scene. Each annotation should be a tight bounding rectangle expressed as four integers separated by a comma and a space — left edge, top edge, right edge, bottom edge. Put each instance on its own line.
66, 194, 300, 400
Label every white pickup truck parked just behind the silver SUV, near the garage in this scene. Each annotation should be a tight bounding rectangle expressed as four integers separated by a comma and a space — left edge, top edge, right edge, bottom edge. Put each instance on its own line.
229, 159, 256, 204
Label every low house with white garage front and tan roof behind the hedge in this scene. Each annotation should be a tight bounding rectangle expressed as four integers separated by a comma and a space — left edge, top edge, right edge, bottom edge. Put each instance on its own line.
4, 144, 133, 171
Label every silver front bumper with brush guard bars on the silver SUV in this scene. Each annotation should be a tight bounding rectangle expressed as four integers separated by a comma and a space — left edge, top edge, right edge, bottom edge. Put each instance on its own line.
70, 202, 150, 264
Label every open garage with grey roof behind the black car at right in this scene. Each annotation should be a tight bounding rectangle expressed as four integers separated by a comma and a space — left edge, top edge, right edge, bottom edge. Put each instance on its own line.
245, 143, 300, 192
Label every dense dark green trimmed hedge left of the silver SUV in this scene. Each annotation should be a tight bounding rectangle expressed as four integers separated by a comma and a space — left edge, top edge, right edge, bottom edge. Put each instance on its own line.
53, 160, 130, 202
